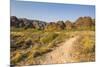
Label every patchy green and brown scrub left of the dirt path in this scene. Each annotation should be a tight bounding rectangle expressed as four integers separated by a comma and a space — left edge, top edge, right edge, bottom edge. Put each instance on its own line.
11, 30, 68, 65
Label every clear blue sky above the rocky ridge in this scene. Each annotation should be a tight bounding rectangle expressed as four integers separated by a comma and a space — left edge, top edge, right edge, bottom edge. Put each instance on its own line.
11, 0, 95, 22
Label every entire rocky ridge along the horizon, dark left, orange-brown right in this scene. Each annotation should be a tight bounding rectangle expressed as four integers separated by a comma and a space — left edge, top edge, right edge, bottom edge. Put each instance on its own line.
10, 16, 95, 30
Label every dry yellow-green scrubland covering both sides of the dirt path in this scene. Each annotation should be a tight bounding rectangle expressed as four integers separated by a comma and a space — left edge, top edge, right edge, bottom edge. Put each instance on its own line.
11, 29, 95, 65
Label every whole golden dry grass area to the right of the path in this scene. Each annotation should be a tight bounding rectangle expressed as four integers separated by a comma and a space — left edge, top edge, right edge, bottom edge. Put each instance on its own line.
71, 31, 95, 62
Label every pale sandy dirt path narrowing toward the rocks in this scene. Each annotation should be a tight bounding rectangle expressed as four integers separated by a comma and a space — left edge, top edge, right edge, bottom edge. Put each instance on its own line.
40, 36, 79, 64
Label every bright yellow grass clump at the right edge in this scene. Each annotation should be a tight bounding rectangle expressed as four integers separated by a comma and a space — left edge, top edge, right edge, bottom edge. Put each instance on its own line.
80, 32, 95, 53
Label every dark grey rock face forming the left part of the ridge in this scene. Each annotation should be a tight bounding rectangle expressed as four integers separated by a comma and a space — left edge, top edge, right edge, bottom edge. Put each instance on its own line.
10, 16, 47, 30
